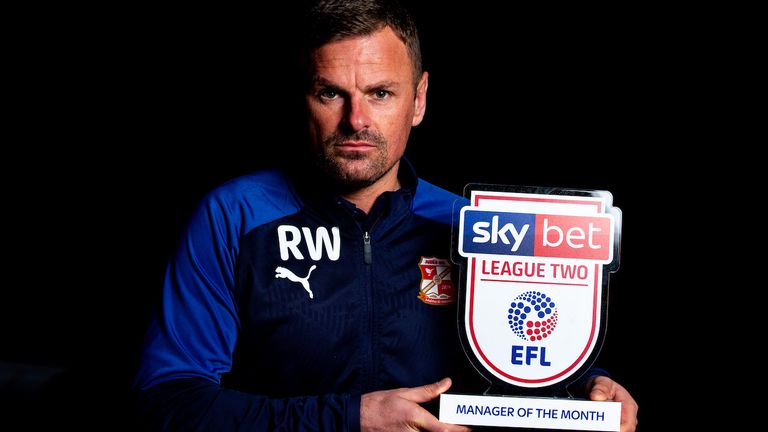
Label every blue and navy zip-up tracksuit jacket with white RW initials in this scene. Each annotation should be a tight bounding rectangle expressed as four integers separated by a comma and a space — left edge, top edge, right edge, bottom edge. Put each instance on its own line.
136, 161, 478, 430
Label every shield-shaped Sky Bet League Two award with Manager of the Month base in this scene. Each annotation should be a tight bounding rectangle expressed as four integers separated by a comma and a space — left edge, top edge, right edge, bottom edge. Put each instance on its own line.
440, 184, 621, 431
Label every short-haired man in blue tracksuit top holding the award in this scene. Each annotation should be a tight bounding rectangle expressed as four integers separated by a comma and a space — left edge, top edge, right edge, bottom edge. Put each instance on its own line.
136, 0, 637, 431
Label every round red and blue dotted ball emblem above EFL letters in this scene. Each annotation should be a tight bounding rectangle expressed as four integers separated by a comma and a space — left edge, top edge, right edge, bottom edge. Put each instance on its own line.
507, 291, 557, 341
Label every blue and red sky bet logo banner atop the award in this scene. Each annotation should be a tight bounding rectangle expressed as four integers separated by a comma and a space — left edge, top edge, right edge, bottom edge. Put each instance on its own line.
459, 207, 613, 263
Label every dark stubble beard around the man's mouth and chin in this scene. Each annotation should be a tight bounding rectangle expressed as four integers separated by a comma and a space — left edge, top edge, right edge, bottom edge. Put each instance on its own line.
317, 129, 394, 188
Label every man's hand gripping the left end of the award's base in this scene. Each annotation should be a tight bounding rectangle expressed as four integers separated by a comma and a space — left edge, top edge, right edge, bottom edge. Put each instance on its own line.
360, 378, 471, 432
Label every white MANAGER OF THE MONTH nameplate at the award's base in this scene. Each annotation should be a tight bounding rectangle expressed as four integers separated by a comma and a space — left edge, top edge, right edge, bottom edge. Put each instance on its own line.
440, 394, 621, 431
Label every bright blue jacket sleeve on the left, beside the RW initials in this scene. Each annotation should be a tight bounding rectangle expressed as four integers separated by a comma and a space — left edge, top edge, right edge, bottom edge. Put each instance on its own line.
134, 191, 360, 431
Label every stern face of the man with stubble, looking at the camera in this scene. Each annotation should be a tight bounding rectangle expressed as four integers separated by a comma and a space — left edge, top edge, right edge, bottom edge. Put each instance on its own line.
306, 27, 427, 187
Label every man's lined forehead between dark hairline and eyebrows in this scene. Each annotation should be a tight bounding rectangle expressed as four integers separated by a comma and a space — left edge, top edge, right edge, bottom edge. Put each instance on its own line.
312, 27, 411, 82
